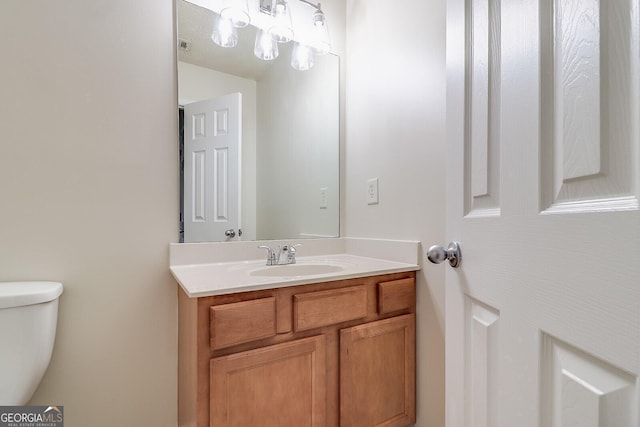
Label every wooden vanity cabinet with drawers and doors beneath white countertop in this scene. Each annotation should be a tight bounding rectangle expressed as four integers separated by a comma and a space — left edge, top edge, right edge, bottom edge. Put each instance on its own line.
178, 272, 415, 427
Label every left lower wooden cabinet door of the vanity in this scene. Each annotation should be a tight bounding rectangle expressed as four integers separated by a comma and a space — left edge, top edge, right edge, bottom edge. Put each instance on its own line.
210, 335, 327, 427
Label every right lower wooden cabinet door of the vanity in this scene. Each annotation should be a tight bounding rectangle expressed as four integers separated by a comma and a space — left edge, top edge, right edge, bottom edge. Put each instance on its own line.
340, 314, 416, 427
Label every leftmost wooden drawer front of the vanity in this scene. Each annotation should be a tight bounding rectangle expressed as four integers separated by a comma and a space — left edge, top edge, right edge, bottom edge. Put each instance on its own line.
210, 297, 276, 350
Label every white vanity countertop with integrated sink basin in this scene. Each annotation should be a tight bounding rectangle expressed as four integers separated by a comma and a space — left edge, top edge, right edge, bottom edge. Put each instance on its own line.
170, 243, 420, 298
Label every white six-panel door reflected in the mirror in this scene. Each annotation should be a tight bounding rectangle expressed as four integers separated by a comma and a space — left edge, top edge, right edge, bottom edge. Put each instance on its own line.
184, 93, 242, 242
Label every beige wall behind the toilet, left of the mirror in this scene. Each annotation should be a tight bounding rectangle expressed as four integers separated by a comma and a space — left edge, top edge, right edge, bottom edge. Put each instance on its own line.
0, 0, 178, 427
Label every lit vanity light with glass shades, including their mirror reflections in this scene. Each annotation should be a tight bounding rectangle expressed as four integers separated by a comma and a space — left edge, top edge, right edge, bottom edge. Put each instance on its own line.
211, 0, 331, 70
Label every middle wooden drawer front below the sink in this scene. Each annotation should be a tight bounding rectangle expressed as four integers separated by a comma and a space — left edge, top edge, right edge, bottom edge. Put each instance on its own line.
293, 285, 367, 331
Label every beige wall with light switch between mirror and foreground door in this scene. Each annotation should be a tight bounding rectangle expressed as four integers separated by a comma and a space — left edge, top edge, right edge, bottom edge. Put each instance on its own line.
344, 0, 445, 427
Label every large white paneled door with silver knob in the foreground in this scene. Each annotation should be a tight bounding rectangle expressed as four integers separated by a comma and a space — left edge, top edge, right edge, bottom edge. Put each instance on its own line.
441, 0, 640, 427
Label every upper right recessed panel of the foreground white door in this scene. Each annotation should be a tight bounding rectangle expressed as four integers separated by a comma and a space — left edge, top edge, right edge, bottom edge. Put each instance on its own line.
540, 0, 638, 212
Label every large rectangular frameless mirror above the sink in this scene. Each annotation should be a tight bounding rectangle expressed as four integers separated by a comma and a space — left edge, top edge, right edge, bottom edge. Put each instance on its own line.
177, 0, 340, 242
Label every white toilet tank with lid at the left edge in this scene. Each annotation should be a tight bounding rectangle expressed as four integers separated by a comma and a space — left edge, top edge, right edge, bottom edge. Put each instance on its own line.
0, 282, 62, 406
